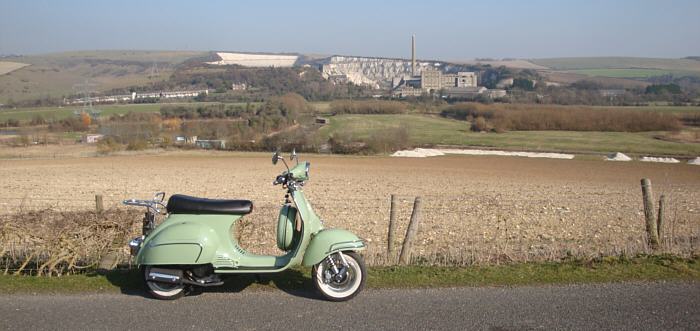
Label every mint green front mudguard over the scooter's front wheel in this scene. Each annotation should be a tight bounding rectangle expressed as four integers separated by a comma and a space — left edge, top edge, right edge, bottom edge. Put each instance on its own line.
302, 229, 366, 267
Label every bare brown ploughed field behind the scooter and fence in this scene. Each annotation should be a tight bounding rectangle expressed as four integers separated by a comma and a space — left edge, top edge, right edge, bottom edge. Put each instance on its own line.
0, 152, 700, 263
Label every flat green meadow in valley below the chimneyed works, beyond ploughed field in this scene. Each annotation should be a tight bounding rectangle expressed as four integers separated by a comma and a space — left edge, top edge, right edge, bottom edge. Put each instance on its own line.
320, 115, 700, 156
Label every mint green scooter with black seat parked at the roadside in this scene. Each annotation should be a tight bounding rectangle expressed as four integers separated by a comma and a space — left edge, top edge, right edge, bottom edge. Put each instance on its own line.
124, 152, 367, 301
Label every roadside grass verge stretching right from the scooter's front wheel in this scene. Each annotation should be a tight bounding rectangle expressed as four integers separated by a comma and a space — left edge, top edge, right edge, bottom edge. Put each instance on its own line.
369, 257, 700, 288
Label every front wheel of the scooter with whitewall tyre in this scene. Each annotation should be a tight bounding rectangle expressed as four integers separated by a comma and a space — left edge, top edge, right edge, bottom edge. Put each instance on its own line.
311, 252, 367, 301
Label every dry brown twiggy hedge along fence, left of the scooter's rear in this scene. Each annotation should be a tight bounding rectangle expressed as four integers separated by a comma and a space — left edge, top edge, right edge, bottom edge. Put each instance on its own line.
0, 209, 143, 276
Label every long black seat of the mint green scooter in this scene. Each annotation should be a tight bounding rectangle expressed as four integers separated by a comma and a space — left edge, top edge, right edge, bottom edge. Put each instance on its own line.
167, 194, 253, 215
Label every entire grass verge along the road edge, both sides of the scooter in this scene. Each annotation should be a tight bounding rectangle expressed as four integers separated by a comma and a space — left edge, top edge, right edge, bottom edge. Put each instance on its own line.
0, 256, 700, 293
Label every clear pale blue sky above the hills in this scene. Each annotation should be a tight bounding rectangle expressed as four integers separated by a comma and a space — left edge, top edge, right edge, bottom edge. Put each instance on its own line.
0, 0, 700, 60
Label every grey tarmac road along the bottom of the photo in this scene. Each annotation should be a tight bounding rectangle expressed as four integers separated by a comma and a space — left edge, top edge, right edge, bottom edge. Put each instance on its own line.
0, 282, 700, 330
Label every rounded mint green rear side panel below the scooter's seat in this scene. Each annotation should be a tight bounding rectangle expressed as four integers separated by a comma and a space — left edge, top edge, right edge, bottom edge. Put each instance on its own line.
136, 222, 218, 265
